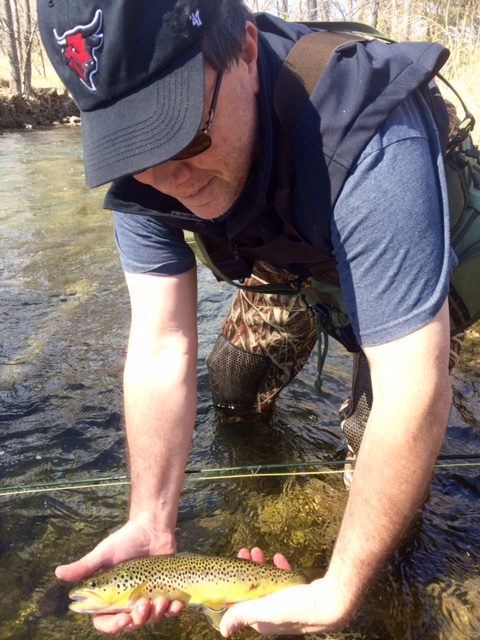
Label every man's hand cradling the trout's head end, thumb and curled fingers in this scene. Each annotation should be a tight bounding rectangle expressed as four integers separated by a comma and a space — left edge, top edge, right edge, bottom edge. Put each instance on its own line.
55, 520, 183, 633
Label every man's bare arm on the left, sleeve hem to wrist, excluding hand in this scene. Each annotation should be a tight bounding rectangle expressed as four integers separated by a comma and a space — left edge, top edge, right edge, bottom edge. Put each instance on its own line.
124, 270, 197, 552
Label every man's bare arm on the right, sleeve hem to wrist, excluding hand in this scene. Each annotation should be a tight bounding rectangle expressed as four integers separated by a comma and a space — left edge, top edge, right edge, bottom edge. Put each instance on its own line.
327, 303, 451, 620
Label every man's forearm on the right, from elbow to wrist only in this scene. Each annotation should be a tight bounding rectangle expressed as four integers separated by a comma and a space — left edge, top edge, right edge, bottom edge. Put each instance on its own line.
327, 378, 450, 609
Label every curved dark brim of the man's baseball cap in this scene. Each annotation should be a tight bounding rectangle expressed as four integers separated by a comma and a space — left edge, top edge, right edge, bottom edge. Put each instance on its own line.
81, 45, 205, 187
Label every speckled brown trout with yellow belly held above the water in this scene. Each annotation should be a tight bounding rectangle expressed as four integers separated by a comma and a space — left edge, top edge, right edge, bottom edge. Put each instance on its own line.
69, 553, 307, 629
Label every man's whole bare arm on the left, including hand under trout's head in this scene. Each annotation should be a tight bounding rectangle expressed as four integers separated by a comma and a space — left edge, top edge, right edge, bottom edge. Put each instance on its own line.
56, 269, 197, 633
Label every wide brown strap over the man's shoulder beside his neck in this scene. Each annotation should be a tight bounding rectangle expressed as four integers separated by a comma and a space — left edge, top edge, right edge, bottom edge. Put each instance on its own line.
273, 31, 365, 131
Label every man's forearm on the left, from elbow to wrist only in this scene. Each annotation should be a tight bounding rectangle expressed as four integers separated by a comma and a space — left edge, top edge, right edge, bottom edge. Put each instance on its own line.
124, 348, 196, 534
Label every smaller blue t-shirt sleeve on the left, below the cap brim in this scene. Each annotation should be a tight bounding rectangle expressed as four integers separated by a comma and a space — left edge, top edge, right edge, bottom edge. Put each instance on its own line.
113, 211, 195, 276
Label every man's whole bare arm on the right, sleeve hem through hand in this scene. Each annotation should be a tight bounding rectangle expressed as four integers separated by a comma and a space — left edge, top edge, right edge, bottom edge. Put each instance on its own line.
221, 302, 451, 636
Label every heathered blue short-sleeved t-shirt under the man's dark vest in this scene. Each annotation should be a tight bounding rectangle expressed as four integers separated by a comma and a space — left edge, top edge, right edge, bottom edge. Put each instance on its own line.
114, 92, 456, 346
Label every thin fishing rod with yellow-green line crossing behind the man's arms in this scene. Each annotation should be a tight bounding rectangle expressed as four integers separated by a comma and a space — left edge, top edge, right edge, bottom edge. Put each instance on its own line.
0, 454, 480, 497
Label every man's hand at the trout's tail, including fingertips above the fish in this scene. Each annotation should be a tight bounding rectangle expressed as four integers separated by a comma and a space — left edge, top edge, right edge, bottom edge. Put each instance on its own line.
220, 548, 353, 638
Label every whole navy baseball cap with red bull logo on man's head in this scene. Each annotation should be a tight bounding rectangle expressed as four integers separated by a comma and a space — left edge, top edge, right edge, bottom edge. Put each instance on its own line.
37, 0, 221, 187
